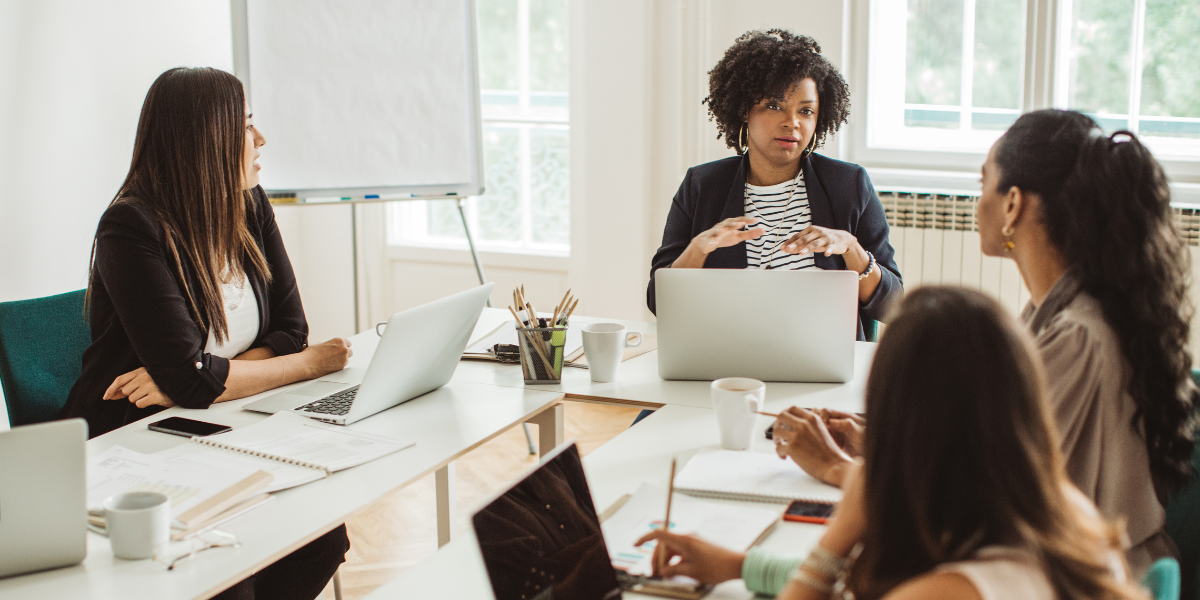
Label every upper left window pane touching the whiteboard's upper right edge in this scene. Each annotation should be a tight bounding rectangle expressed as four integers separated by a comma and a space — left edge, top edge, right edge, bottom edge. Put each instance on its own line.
475, 0, 517, 92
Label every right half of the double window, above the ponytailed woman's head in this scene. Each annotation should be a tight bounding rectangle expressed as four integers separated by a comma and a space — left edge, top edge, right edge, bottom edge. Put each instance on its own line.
1055, 0, 1200, 158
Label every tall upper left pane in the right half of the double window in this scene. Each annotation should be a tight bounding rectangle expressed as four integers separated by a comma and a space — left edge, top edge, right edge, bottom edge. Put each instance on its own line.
1067, 0, 1134, 115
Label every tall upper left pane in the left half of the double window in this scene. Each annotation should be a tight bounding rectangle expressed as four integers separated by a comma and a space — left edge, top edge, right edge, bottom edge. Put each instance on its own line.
905, 0, 962, 106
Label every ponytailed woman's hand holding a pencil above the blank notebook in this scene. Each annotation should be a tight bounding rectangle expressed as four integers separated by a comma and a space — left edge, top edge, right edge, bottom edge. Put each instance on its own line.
772, 407, 854, 487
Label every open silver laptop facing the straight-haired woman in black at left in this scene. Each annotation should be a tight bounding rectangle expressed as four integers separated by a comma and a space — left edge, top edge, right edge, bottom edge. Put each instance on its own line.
242, 283, 494, 425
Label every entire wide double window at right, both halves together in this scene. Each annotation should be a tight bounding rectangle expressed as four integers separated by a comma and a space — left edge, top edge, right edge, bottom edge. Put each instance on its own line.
865, 0, 1200, 160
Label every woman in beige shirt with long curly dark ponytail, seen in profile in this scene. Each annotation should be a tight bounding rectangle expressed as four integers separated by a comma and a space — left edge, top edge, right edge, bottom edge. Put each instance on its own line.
978, 110, 1196, 572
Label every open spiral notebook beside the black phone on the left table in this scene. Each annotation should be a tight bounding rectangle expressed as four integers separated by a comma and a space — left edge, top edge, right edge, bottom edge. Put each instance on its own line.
157, 413, 413, 492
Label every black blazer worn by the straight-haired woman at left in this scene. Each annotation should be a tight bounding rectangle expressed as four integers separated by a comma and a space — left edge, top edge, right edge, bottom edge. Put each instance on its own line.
61, 187, 308, 437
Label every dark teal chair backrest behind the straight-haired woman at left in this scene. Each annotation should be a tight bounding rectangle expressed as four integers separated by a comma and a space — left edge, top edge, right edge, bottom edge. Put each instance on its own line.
0, 289, 91, 427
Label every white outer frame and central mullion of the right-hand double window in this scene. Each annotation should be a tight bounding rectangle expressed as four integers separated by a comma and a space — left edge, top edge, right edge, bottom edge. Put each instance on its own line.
842, 0, 1200, 182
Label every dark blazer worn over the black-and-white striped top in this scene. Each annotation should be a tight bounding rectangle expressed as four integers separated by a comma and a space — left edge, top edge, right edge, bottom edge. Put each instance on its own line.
646, 154, 904, 340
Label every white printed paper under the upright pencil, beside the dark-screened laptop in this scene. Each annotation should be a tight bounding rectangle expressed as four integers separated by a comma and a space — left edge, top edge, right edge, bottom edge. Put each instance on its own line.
601, 484, 782, 576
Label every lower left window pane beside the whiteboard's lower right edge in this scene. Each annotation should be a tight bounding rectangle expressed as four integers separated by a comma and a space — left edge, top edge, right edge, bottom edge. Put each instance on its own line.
475, 126, 521, 241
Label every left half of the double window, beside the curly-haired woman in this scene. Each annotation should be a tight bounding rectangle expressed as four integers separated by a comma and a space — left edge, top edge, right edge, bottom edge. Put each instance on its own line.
868, 0, 1025, 151
